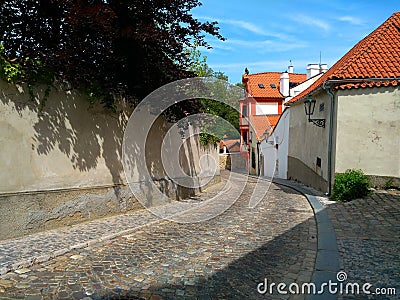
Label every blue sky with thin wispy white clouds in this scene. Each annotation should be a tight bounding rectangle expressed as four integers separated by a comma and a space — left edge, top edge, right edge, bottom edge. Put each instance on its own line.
192, 0, 400, 83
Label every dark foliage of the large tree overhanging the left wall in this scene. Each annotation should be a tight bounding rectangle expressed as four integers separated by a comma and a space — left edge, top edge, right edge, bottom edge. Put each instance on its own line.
0, 0, 223, 105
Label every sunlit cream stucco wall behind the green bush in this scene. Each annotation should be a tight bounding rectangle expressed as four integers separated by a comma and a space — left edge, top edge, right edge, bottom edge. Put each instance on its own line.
335, 87, 400, 177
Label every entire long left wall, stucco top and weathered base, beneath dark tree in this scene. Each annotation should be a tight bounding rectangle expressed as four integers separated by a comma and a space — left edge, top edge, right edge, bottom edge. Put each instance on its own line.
0, 81, 219, 240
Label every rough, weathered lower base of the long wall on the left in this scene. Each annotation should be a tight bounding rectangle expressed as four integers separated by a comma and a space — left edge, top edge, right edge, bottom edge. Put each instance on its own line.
0, 185, 138, 240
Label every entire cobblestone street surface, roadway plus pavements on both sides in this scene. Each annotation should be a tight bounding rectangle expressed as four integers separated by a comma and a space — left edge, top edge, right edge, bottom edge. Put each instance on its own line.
0, 173, 400, 300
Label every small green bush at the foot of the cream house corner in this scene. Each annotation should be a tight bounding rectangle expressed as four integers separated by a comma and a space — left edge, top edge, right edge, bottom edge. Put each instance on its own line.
331, 169, 370, 202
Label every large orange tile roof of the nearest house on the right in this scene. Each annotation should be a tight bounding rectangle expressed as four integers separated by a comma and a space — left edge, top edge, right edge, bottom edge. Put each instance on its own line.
289, 12, 400, 103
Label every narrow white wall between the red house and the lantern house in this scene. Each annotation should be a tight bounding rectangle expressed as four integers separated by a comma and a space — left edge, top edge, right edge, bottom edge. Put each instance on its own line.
260, 109, 290, 179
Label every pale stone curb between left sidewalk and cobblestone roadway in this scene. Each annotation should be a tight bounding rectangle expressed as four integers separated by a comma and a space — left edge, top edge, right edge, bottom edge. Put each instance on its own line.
0, 182, 232, 275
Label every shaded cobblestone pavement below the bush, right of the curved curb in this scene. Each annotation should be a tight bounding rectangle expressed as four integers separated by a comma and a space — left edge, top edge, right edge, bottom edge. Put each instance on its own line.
326, 191, 400, 299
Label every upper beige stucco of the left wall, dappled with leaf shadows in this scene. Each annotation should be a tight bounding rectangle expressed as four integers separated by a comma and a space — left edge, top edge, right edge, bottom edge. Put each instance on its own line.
0, 81, 218, 194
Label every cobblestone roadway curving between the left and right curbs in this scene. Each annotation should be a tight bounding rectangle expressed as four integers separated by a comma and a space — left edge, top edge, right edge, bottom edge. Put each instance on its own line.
0, 175, 317, 299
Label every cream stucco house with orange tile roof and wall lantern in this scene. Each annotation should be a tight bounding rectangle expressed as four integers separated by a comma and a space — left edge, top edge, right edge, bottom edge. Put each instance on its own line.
288, 12, 400, 194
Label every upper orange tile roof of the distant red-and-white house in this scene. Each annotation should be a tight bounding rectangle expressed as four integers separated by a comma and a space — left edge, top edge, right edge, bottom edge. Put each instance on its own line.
242, 72, 307, 98
